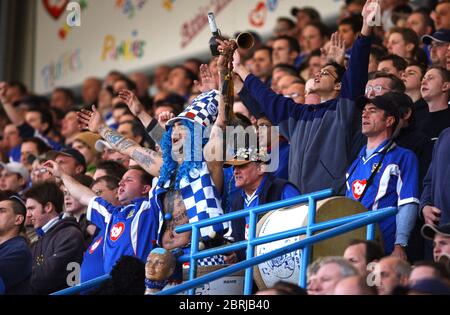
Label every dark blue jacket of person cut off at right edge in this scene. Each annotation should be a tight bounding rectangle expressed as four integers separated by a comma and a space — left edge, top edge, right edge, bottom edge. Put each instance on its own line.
420, 128, 450, 225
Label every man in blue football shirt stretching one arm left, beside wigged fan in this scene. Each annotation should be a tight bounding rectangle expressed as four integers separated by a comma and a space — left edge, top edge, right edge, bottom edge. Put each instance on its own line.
44, 161, 162, 280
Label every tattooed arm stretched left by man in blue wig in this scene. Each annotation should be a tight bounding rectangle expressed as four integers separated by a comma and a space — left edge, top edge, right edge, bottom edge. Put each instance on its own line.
99, 125, 162, 177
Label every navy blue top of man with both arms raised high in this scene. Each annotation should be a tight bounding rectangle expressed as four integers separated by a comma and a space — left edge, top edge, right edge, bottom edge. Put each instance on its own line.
244, 36, 371, 193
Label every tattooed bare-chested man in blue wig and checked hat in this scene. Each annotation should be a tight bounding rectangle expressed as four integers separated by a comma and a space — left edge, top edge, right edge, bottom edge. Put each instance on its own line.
80, 70, 228, 263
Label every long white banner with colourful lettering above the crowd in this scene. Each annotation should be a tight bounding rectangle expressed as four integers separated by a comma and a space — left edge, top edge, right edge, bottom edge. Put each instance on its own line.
34, 0, 344, 93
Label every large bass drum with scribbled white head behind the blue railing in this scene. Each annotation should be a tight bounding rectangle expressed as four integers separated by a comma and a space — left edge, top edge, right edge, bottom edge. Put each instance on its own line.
254, 197, 382, 290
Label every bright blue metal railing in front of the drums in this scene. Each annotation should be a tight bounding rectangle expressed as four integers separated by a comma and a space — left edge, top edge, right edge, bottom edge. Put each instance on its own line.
53, 189, 398, 295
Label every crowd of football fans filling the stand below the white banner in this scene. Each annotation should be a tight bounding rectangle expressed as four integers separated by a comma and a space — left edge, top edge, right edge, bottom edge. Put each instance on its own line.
0, 0, 450, 295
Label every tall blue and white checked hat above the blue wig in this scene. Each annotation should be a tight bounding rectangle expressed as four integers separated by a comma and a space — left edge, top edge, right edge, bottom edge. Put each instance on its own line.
166, 90, 220, 127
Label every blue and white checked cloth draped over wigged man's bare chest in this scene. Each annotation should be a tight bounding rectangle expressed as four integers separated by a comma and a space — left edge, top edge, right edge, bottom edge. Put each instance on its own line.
150, 162, 229, 239
